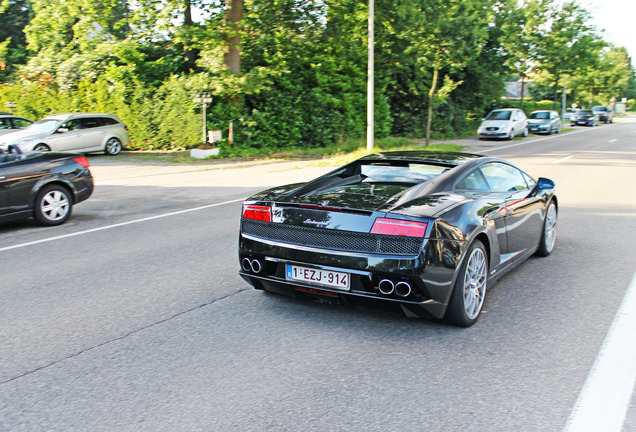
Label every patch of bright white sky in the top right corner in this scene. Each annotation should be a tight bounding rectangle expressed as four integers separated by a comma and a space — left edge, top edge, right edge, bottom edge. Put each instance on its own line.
579, 0, 636, 64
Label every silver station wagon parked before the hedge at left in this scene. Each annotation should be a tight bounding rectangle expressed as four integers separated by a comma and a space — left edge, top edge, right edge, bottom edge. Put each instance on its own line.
0, 113, 129, 156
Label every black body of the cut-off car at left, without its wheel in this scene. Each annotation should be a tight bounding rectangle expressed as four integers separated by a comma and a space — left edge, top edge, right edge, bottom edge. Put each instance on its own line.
0, 152, 93, 222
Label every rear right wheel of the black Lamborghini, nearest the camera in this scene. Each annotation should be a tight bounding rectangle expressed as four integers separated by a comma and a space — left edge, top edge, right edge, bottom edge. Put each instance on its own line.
446, 240, 488, 327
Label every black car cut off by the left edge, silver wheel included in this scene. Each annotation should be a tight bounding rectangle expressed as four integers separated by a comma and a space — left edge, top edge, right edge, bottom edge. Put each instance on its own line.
0, 146, 93, 226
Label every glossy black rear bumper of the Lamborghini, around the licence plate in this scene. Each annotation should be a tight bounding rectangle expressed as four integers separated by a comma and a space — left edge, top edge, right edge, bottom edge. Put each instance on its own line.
239, 235, 464, 318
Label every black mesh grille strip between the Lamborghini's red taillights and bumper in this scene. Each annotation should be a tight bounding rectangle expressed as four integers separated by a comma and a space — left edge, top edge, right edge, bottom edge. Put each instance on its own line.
241, 219, 422, 255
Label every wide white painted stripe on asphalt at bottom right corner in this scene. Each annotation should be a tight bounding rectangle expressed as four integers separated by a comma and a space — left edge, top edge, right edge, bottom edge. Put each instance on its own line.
565, 274, 636, 432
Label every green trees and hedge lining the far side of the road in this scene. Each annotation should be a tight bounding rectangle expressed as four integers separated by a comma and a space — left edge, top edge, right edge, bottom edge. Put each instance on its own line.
0, 0, 636, 152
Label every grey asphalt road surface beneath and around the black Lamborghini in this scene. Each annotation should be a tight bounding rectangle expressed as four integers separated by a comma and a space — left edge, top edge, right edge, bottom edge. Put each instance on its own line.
0, 119, 636, 432
